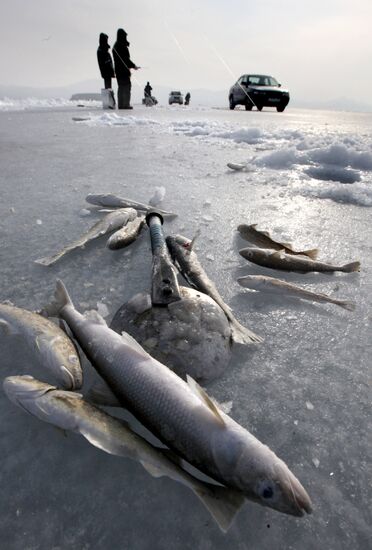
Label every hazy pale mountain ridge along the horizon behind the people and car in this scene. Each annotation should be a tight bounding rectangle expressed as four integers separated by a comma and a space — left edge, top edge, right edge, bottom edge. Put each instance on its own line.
0, 79, 372, 113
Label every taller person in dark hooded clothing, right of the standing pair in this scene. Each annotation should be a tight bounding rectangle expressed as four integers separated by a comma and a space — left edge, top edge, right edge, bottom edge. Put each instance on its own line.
112, 29, 138, 109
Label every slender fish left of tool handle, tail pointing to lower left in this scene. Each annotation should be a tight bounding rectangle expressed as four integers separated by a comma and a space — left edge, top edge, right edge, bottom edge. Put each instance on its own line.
35, 208, 137, 266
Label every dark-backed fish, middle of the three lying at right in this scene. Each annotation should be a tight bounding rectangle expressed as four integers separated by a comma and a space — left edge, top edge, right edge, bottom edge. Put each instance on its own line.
239, 248, 360, 273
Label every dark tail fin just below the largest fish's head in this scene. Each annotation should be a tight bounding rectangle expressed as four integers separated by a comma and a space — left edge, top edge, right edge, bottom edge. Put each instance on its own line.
193, 485, 245, 533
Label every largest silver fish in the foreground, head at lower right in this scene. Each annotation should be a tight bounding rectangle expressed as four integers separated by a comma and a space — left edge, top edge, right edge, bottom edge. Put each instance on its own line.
45, 281, 311, 516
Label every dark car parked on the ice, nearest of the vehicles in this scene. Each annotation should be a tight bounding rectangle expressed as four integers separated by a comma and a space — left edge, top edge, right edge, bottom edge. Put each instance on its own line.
229, 74, 289, 113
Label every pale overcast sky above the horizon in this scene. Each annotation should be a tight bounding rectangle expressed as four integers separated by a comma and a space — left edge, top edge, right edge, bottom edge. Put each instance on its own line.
0, 0, 372, 105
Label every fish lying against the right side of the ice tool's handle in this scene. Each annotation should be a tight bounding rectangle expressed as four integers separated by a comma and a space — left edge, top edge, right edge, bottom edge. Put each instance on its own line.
166, 235, 263, 344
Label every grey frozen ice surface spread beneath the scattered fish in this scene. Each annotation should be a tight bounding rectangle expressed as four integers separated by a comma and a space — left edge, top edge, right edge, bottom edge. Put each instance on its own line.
0, 105, 372, 550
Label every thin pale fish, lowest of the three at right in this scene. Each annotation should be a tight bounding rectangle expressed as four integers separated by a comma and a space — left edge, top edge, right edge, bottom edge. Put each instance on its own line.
238, 275, 355, 311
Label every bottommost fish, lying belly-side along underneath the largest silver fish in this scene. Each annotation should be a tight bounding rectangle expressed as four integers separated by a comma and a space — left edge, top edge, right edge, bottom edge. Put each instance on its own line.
3, 376, 244, 531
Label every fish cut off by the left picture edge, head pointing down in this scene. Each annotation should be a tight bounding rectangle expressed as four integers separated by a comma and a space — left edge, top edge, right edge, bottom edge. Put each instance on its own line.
0, 304, 83, 390
